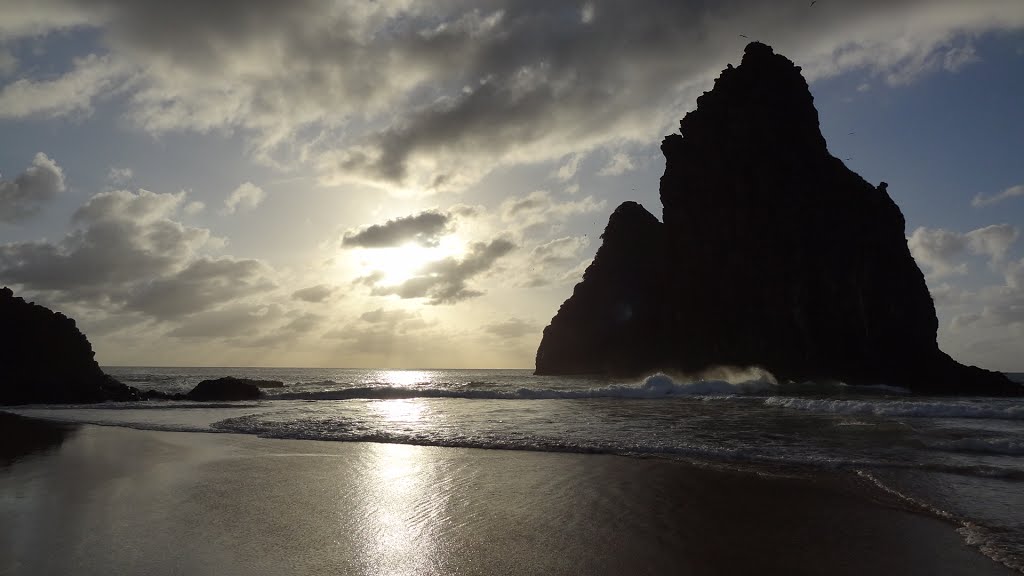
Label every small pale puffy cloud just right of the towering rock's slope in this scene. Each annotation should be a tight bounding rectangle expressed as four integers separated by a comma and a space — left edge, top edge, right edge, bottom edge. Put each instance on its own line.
907, 223, 1018, 279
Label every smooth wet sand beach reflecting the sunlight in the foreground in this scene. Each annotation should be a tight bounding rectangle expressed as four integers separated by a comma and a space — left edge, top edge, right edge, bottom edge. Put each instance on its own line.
0, 414, 1014, 575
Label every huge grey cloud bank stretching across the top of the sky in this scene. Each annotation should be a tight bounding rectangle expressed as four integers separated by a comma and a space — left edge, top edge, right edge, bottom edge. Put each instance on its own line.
0, 0, 1024, 191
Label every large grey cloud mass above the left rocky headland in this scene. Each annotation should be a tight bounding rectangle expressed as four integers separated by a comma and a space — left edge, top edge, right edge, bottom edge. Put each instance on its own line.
0, 190, 288, 325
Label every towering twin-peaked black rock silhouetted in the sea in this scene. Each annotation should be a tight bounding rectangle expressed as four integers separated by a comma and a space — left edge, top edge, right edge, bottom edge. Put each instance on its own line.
537, 42, 1024, 394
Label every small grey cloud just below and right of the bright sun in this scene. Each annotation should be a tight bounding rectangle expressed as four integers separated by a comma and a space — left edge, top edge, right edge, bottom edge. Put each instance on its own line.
371, 238, 515, 304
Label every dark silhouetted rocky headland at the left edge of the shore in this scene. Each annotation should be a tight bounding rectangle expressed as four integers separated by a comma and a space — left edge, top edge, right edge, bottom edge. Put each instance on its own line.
0, 288, 140, 405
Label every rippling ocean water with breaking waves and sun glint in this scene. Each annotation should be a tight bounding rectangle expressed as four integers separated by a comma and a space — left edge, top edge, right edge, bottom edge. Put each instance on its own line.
7, 367, 1024, 573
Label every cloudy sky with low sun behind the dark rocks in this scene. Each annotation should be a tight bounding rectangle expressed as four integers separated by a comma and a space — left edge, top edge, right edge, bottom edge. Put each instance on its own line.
0, 0, 1024, 371
